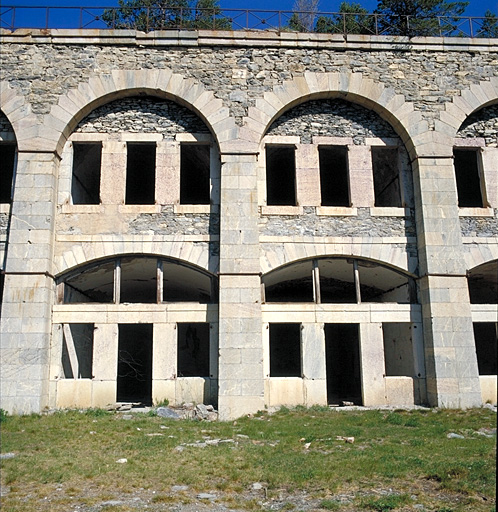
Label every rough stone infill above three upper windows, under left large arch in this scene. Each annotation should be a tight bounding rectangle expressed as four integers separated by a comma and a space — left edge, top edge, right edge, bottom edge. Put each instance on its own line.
75, 97, 209, 134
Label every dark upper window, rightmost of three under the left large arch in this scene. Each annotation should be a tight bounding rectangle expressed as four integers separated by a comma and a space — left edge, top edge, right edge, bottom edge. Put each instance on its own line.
180, 144, 211, 204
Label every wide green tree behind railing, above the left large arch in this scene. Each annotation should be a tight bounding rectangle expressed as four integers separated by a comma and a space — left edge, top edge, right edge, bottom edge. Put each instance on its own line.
102, 0, 232, 32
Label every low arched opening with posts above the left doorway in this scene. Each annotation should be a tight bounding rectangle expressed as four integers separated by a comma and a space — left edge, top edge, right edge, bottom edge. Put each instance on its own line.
56, 253, 218, 304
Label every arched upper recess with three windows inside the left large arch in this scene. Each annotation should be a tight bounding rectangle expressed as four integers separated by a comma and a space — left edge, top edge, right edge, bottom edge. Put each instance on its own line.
64, 96, 212, 205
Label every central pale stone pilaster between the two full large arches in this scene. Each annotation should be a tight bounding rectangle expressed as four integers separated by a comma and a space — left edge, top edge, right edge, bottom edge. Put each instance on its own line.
219, 149, 264, 419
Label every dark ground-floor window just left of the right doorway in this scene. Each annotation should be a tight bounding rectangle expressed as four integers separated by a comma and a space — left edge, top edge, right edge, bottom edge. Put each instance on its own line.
270, 324, 302, 377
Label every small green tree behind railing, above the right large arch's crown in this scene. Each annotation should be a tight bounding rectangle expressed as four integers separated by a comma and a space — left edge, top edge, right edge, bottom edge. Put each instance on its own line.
316, 2, 375, 34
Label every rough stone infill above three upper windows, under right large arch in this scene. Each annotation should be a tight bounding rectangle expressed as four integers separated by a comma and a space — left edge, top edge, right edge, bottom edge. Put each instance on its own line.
267, 99, 399, 145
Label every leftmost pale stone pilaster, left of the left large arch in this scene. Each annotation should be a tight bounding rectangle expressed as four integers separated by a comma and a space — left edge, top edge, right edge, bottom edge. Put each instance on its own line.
0, 152, 58, 413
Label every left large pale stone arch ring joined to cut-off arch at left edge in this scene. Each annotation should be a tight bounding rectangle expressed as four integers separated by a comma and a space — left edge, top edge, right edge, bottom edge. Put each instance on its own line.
1, 69, 237, 154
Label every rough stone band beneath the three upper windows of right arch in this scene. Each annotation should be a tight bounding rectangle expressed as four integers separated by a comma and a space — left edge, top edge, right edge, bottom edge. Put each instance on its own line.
260, 206, 416, 237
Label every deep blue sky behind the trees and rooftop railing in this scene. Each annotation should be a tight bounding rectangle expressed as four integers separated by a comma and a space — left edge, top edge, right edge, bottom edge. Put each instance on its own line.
0, 0, 498, 28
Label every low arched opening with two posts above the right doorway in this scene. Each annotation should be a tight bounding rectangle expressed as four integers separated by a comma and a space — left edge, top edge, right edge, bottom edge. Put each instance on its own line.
261, 255, 417, 304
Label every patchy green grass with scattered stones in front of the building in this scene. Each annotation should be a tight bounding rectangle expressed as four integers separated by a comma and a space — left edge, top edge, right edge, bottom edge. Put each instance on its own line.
1, 407, 496, 512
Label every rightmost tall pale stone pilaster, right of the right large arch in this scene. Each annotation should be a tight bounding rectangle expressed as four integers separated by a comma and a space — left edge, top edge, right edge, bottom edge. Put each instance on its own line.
414, 155, 481, 408
